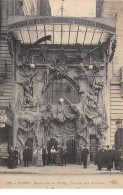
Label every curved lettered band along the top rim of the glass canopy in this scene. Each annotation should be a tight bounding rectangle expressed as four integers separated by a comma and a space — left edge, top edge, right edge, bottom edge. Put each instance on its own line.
8, 17, 116, 33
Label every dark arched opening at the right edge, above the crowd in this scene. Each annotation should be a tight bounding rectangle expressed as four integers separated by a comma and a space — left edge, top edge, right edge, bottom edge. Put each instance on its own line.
115, 129, 123, 150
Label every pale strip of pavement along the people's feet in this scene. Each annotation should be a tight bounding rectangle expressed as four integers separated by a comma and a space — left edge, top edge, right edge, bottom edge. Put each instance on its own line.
0, 164, 123, 175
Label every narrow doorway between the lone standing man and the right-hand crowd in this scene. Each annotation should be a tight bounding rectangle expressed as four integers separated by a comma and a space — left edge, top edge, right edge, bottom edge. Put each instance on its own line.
90, 135, 99, 162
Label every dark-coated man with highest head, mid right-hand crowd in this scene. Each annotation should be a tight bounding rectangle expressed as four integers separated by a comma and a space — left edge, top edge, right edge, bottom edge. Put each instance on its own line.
106, 145, 113, 171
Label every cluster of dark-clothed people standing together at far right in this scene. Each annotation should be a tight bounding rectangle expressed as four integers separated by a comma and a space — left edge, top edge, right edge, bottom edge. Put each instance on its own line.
95, 145, 123, 171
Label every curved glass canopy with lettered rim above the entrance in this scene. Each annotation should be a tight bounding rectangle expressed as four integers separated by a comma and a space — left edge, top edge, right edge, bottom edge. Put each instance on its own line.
9, 17, 115, 46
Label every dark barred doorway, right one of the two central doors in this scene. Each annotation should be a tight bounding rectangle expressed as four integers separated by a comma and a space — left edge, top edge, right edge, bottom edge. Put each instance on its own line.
67, 139, 76, 164
